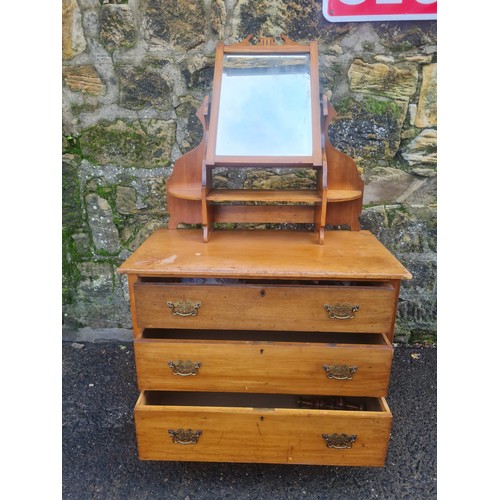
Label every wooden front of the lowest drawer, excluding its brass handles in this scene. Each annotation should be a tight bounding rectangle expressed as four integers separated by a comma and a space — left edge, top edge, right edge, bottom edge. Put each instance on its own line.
134, 392, 392, 466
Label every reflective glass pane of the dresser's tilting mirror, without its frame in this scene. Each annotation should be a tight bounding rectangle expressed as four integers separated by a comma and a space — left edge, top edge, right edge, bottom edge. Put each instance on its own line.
215, 54, 313, 156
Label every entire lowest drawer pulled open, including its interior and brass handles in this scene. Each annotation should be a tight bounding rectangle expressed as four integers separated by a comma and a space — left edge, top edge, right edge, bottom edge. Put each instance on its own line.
134, 391, 392, 467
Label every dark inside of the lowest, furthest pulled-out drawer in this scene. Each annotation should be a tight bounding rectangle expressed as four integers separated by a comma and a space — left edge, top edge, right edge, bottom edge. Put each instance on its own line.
138, 391, 385, 412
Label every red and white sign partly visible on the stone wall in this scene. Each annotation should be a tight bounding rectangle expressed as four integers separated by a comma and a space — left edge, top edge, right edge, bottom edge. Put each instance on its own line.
323, 0, 437, 23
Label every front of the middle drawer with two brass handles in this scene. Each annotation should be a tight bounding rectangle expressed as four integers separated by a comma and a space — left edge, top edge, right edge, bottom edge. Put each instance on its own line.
134, 335, 392, 396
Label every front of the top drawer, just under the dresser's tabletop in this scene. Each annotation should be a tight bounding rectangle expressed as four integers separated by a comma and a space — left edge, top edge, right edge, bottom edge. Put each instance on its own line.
134, 282, 396, 333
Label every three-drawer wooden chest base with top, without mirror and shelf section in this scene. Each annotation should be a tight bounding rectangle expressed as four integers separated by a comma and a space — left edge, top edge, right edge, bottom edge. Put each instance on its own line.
119, 227, 411, 466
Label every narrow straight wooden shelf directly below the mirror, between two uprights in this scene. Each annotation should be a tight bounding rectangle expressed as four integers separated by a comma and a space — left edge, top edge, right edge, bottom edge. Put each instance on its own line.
207, 189, 321, 203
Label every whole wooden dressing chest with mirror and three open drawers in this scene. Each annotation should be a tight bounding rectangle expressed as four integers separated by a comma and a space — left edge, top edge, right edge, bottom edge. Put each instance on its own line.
118, 36, 411, 466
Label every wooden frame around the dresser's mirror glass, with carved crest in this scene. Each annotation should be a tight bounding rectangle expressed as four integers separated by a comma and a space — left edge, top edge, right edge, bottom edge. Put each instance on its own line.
206, 35, 322, 167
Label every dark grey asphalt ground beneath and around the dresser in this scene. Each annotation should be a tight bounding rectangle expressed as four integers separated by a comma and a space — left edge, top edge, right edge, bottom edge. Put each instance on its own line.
62, 343, 437, 500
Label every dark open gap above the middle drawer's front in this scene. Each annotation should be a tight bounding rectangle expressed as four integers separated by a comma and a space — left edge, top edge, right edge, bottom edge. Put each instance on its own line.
140, 328, 389, 345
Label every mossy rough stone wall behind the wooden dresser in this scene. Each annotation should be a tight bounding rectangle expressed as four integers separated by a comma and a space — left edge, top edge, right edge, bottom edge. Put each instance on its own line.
62, 0, 437, 342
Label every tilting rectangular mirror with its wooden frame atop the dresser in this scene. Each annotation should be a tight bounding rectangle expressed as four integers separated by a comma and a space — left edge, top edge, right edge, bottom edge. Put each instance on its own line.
207, 38, 321, 165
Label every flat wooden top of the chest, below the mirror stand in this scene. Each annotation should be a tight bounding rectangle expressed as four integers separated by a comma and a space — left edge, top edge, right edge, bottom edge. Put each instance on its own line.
118, 229, 411, 280
